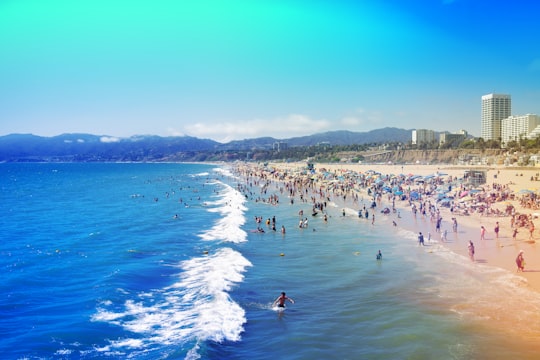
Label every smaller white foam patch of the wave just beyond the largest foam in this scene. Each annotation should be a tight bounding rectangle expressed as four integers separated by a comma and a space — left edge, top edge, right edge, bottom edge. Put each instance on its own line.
200, 184, 247, 243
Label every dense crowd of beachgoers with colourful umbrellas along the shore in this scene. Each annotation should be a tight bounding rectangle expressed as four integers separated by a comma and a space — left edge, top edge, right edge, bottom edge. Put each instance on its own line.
231, 164, 540, 278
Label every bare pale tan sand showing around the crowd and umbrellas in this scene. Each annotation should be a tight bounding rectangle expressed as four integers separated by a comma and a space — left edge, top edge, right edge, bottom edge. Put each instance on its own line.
268, 163, 540, 292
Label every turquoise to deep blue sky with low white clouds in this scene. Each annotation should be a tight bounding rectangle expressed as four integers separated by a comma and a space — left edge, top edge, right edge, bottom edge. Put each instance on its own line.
0, 0, 540, 142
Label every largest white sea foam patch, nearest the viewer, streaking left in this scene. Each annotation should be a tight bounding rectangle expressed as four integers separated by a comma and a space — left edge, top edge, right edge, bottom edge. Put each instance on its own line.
92, 248, 251, 358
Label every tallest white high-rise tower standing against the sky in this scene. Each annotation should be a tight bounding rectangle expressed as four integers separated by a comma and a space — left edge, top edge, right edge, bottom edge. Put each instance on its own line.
482, 94, 512, 140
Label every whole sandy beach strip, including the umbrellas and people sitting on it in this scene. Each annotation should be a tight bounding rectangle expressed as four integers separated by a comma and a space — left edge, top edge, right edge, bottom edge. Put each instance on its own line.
252, 163, 540, 292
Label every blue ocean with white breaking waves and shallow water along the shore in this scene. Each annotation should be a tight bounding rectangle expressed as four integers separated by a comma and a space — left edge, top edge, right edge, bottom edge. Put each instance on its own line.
0, 163, 540, 359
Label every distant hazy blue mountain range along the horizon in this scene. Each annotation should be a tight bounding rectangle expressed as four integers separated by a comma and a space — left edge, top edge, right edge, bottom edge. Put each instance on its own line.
0, 128, 412, 162
